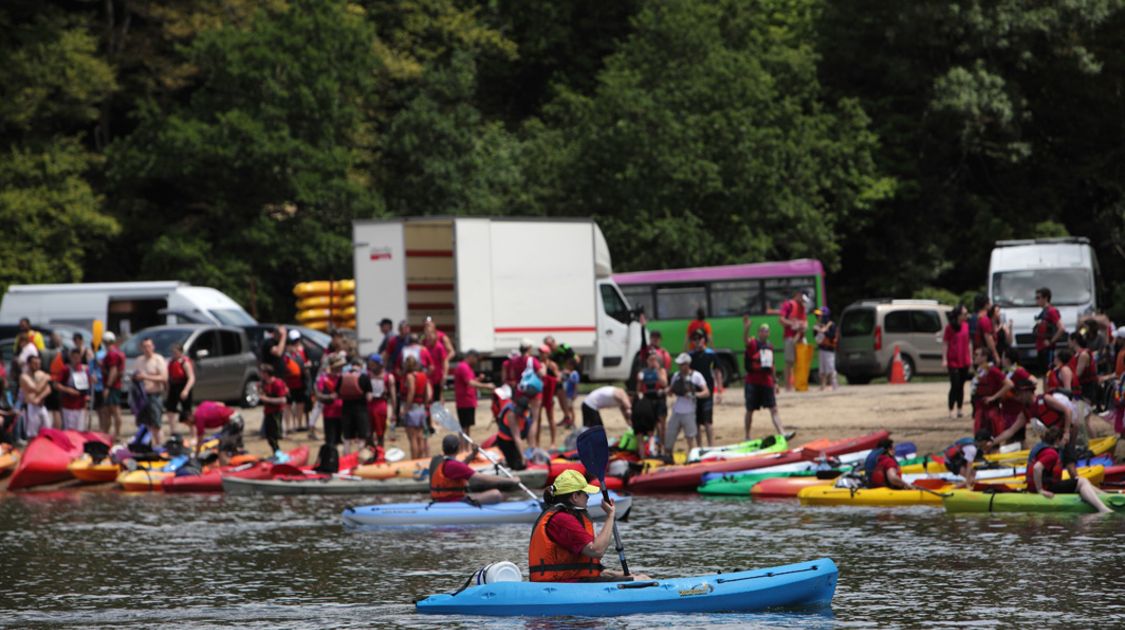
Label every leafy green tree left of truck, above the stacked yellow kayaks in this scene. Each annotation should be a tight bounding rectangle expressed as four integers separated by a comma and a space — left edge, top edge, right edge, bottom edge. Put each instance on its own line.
109, 0, 381, 318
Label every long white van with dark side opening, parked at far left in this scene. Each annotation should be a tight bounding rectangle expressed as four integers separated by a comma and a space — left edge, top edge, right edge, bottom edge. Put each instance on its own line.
0, 281, 258, 336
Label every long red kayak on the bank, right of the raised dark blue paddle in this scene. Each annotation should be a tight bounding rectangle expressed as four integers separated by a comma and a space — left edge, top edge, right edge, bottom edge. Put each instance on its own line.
628, 431, 890, 492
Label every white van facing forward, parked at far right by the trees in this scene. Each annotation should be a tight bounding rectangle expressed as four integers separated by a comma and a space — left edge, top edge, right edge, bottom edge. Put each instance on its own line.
988, 237, 1101, 365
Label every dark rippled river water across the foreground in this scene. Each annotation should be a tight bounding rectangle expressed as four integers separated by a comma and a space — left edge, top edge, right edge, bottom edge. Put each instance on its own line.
0, 492, 1125, 629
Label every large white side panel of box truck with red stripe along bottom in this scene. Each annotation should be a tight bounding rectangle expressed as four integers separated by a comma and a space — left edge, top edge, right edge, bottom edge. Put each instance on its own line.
490, 221, 597, 353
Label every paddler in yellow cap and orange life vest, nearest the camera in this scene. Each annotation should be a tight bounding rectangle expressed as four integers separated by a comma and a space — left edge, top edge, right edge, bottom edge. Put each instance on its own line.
528, 470, 650, 582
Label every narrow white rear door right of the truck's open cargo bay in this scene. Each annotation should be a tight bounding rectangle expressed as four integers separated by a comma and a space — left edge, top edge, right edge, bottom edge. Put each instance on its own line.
453, 218, 496, 354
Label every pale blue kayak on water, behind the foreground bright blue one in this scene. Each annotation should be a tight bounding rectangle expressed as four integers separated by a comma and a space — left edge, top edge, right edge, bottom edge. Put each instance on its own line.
342, 491, 632, 527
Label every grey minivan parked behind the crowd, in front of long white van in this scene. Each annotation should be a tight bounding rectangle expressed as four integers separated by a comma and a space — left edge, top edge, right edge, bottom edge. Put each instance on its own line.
122, 324, 259, 407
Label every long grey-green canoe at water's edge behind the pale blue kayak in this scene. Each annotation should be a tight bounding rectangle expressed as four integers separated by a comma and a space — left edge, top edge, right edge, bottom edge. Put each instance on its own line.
222, 468, 547, 495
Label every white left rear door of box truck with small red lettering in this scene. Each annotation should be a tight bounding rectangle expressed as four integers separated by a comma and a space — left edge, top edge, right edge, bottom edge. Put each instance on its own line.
352, 222, 406, 354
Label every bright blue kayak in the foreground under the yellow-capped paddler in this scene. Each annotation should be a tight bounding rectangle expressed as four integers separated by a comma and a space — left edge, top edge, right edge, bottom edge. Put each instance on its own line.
415, 558, 837, 617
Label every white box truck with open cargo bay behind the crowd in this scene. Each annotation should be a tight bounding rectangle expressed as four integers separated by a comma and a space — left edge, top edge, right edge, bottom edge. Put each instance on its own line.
352, 217, 640, 380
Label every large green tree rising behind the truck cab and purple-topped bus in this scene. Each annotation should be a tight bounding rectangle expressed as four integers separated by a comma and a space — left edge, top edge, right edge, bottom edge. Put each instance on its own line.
527, 0, 893, 275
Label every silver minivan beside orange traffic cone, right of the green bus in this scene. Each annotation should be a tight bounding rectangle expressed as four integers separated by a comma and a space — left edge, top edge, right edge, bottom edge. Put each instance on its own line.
836, 299, 953, 385
